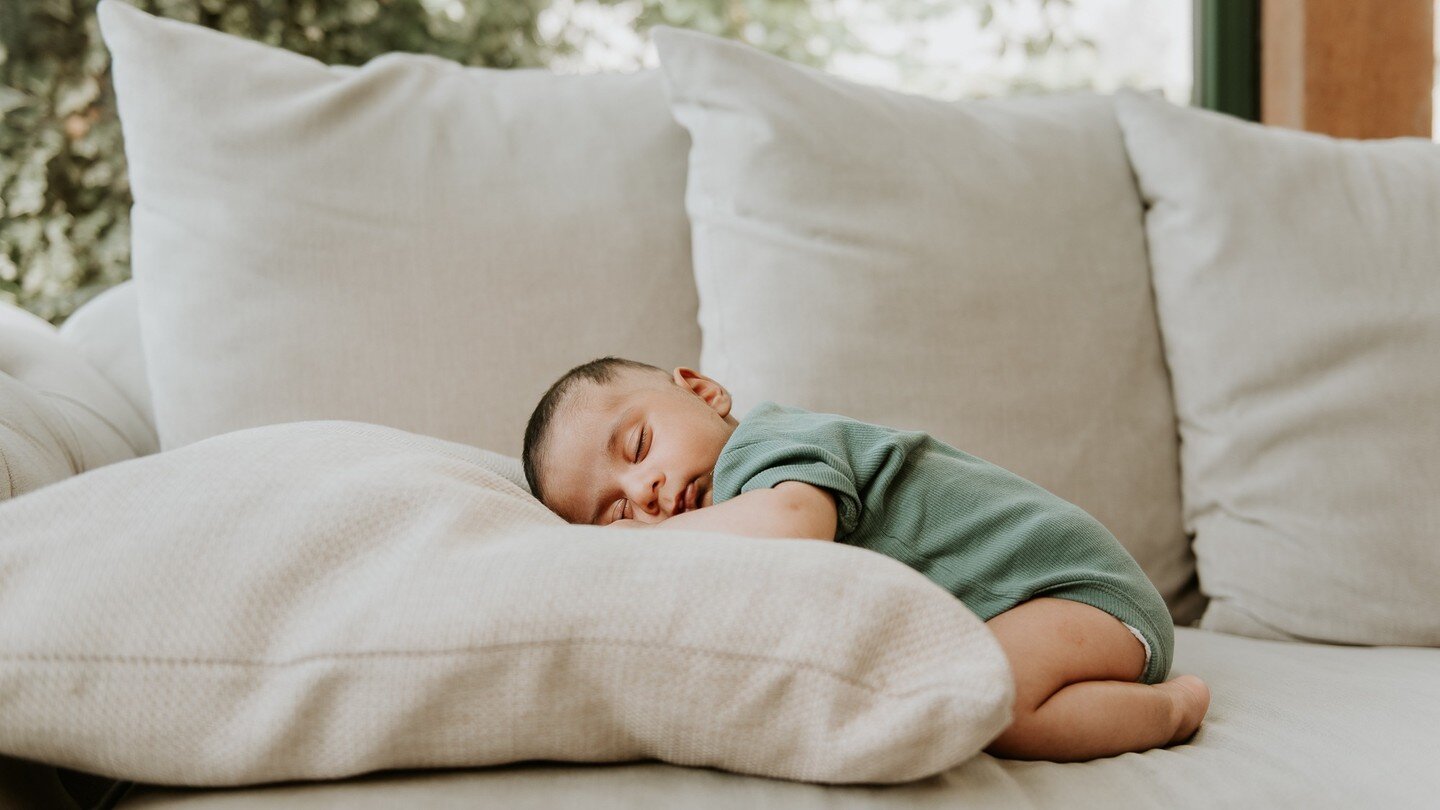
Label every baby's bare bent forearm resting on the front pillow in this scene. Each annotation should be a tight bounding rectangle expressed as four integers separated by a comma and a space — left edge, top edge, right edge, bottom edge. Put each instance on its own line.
609, 481, 838, 540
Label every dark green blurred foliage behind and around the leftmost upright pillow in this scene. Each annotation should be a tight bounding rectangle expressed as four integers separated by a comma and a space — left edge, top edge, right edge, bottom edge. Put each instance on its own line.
0, 0, 569, 323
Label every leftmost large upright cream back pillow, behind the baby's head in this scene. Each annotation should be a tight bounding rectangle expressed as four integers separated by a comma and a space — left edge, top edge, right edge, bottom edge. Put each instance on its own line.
99, 0, 700, 455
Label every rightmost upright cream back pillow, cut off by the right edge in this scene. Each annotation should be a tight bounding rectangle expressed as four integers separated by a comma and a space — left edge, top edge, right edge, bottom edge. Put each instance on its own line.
1119, 92, 1440, 646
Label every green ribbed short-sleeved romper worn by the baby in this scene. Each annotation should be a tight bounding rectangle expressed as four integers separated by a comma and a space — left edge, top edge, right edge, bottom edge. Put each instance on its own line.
711, 402, 1175, 683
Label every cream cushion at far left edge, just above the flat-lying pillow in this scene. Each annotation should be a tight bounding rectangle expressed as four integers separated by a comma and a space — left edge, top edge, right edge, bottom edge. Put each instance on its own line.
0, 304, 156, 495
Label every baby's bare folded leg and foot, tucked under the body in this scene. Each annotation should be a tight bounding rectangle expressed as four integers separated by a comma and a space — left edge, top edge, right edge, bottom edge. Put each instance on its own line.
986, 597, 1210, 762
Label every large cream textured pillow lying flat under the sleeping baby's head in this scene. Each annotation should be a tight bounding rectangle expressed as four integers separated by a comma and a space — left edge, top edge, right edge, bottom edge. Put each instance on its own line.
0, 422, 1014, 785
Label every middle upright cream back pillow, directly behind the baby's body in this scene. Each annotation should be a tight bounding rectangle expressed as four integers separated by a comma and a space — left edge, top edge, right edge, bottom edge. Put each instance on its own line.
655, 29, 1200, 623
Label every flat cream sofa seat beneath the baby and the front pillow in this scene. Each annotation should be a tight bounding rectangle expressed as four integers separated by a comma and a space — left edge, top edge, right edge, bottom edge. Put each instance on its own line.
121, 627, 1440, 810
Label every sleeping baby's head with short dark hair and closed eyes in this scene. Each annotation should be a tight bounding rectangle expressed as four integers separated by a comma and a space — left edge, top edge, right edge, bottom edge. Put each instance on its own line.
523, 357, 739, 525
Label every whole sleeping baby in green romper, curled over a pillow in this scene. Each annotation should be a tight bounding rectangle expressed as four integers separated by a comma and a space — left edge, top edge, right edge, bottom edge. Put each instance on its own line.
523, 357, 1210, 761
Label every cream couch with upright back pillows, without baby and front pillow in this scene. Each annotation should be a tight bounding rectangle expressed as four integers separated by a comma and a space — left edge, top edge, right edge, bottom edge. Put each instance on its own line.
0, 0, 1440, 809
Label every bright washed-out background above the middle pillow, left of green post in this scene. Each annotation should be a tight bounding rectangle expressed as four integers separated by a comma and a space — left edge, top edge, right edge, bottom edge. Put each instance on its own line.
540, 0, 1192, 102
